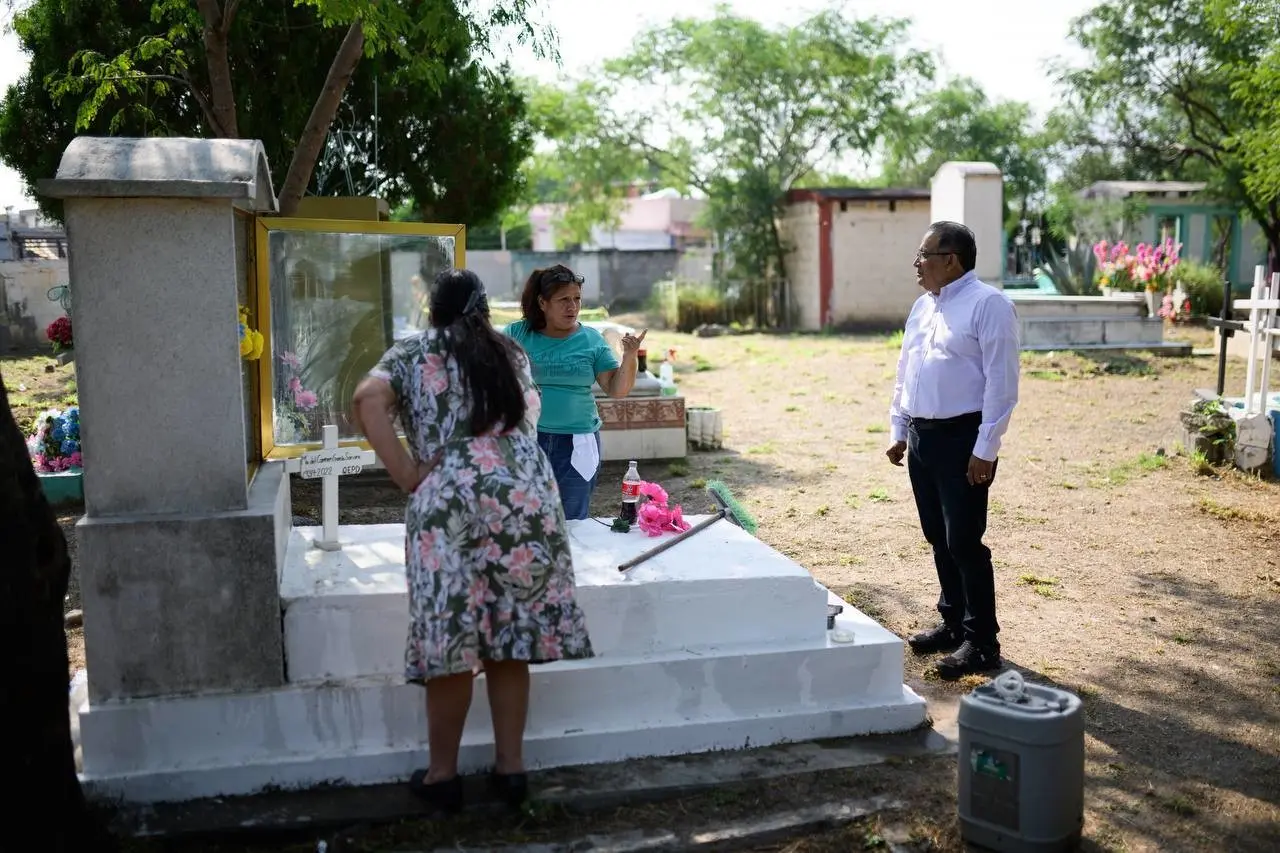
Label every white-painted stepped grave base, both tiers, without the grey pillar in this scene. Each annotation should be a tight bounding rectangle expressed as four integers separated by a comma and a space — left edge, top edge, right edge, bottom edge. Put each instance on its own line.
81, 517, 925, 802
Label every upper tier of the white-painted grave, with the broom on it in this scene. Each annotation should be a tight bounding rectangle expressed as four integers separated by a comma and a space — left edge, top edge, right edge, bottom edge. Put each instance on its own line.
280, 516, 827, 681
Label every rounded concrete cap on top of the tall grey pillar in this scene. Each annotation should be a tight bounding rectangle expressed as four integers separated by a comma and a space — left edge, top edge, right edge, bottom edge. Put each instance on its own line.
37, 136, 276, 213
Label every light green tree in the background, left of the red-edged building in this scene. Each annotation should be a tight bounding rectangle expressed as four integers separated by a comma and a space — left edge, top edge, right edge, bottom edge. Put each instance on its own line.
570, 5, 933, 285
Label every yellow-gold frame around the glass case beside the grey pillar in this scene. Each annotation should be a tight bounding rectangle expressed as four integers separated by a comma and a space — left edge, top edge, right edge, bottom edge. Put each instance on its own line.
253, 216, 467, 460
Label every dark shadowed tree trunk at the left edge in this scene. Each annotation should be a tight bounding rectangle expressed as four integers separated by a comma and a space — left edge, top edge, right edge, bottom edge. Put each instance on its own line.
0, 378, 116, 852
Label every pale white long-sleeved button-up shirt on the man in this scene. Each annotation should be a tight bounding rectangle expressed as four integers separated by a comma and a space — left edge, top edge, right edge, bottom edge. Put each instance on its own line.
890, 272, 1019, 461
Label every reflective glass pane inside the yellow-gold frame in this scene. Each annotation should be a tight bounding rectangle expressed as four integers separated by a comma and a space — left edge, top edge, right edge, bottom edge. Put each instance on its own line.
268, 229, 457, 447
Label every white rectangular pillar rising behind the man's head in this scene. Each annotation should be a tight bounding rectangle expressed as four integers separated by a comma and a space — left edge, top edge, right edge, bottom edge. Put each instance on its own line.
929, 163, 1005, 287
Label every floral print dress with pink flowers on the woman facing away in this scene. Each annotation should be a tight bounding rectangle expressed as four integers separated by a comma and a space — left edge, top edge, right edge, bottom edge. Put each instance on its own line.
370, 329, 593, 683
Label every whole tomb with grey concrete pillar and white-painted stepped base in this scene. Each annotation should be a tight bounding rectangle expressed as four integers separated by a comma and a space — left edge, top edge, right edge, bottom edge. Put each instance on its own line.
41, 134, 925, 802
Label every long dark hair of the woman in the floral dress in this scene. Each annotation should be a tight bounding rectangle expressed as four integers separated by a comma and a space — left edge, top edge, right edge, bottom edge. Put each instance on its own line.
431, 269, 525, 435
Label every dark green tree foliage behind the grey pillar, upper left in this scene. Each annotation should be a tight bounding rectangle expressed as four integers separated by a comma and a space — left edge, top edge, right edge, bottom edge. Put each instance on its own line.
0, 0, 536, 223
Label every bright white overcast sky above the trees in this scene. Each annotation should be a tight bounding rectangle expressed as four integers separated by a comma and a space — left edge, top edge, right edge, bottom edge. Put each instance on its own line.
0, 0, 1096, 209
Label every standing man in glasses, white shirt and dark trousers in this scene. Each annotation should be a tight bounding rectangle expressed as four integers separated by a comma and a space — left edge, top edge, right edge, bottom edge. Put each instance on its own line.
886, 222, 1018, 679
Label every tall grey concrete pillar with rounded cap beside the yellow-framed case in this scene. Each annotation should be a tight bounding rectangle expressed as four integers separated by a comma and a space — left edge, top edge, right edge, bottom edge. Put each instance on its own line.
40, 137, 289, 703
